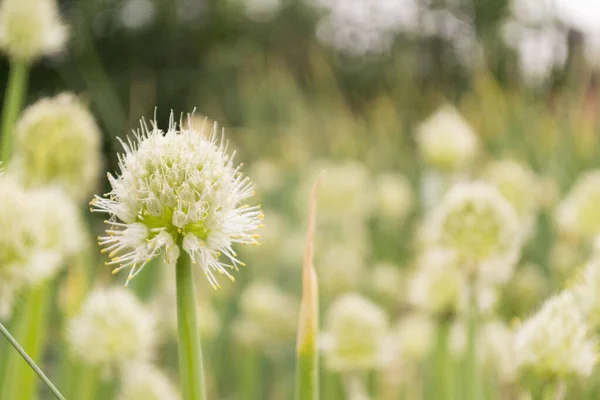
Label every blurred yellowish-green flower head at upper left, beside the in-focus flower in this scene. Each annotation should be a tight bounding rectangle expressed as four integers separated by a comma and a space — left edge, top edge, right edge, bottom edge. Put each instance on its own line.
13, 93, 101, 200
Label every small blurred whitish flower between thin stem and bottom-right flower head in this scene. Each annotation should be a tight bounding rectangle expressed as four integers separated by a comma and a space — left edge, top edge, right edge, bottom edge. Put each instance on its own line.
478, 320, 518, 382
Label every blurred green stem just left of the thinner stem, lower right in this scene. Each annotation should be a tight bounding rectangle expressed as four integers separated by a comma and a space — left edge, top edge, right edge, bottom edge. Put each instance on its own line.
434, 318, 455, 400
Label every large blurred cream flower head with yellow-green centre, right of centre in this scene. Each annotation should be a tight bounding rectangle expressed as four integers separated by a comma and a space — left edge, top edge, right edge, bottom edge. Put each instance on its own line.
427, 183, 522, 282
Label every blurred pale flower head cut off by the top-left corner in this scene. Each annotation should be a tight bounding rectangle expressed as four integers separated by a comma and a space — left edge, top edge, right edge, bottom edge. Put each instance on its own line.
0, 0, 67, 61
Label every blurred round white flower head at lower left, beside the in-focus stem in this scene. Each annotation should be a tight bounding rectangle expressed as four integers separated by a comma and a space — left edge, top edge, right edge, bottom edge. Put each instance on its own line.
67, 287, 156, 371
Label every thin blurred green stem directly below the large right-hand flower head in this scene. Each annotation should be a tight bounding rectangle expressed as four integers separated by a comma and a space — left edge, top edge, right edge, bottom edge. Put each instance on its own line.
465, 284, 480, 400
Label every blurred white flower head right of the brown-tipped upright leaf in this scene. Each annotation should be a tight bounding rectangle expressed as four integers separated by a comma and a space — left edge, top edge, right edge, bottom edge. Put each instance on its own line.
321, 294, 391, 372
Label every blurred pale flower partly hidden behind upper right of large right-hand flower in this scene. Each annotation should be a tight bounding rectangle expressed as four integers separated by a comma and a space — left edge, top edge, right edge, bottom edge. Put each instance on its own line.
482, 160, 541, 234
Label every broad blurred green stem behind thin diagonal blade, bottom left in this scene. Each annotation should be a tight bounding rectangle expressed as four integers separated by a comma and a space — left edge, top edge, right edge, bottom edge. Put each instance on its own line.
0, 283, 57, 400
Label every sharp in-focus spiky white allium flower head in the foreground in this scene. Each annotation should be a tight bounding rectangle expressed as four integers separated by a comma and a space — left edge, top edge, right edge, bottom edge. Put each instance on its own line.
91, 114, 263, 288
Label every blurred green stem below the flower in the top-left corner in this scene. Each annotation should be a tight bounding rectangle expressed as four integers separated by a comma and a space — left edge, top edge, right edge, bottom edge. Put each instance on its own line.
0, 60, 29, 163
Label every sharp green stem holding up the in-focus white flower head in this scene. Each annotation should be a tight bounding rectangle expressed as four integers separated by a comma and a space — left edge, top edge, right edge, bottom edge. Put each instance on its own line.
176, 252, 206, 400
